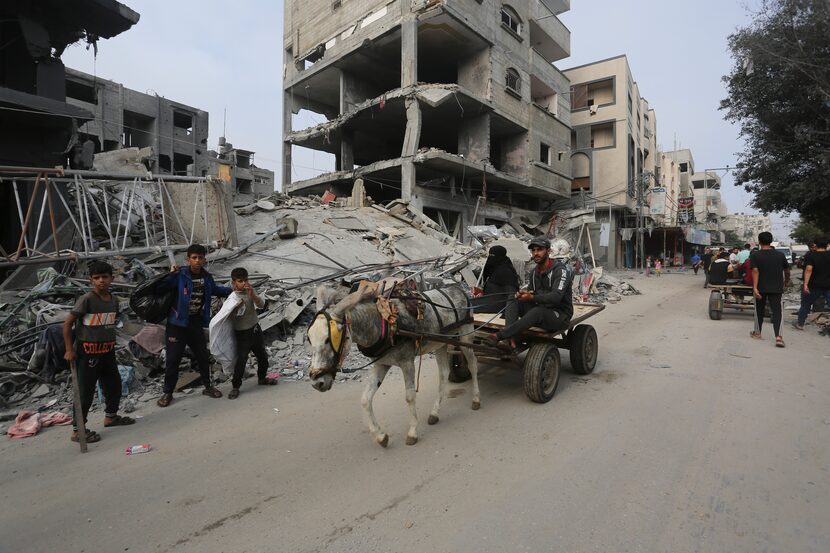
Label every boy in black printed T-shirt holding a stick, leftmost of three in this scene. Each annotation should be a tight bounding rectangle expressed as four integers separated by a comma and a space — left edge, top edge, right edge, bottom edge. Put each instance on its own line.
63, 261, 135, 443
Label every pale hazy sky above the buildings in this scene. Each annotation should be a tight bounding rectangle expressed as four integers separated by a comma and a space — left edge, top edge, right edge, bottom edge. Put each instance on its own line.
63, 0, 788, 238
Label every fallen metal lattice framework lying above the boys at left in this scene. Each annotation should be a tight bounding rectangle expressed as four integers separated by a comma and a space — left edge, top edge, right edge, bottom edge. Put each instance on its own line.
0, 166, 231, 268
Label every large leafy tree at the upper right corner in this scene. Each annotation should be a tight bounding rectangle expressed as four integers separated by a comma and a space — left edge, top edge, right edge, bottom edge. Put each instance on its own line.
721, 0, 830, 231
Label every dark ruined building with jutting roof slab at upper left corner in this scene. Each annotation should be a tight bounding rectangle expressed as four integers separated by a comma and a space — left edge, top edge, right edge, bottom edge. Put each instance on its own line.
0, 0, 139, 279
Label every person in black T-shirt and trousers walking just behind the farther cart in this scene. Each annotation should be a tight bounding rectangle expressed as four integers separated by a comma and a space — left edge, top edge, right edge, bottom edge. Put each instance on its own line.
749, 232, 790, 348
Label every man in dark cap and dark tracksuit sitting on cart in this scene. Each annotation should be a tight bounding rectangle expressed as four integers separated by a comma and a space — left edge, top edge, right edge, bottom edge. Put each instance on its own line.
487, 237, 573, 344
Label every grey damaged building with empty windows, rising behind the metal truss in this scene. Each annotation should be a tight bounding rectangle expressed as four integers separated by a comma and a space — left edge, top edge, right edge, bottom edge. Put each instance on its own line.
66, 68, 209, 176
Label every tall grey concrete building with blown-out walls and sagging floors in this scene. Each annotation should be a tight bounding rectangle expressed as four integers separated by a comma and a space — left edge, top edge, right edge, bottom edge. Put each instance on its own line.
283, 0, 571, 231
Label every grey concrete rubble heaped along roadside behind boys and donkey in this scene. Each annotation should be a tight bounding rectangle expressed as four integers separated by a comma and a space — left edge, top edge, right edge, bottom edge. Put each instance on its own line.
0, 191, 639, 432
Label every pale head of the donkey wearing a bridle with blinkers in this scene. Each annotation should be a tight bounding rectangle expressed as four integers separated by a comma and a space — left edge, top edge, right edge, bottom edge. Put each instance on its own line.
308, 286, 376, 392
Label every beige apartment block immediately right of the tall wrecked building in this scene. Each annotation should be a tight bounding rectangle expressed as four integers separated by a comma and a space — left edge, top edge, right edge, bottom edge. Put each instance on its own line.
564, 55, 659, 267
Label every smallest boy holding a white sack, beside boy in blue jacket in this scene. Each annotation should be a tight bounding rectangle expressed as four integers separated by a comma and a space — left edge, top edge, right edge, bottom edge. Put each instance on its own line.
210, 267, 277, 399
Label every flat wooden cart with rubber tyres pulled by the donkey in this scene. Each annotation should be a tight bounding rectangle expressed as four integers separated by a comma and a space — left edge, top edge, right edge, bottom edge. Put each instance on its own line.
453, 303, 605, 403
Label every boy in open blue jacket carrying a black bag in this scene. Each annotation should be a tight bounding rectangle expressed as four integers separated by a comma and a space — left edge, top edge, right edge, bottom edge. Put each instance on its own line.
157, 244, 231, 407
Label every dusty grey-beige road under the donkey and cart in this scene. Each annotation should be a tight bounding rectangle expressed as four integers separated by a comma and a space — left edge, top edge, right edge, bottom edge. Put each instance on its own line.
0, 274, 830, 553
